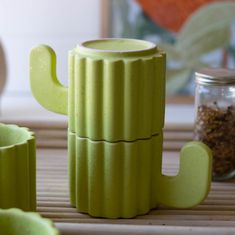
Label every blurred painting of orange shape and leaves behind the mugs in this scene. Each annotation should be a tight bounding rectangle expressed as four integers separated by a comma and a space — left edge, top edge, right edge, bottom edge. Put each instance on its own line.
107, 0, 235, 98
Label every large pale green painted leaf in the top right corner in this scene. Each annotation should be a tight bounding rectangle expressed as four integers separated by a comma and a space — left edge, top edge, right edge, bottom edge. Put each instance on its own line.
175, 2, 235, 59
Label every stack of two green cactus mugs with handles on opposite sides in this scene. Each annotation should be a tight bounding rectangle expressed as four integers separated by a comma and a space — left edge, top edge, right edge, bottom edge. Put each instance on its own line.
30, 39, 211, 218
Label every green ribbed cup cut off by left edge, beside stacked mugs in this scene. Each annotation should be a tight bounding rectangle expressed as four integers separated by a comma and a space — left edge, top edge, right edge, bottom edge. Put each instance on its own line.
0, 124, 36, 211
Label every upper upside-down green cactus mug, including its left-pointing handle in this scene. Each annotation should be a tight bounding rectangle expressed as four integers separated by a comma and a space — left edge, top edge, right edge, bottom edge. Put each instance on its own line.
30, 39, 165, 142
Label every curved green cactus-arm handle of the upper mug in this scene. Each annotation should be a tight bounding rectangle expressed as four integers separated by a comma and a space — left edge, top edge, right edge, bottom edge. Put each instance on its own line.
30, 45, 68, 114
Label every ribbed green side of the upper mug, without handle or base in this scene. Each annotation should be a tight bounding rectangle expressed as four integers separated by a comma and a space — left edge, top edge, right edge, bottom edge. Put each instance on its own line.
69, 51, 165, 141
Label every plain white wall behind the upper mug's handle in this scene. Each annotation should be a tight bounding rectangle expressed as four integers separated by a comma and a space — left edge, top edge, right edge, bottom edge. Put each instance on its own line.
0, 0, 100, 95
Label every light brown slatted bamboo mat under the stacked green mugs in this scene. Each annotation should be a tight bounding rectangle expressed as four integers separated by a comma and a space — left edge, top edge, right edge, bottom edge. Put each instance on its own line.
31, 125, 235, 235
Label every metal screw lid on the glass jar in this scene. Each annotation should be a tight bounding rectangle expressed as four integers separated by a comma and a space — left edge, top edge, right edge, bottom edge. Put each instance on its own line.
195, 68, 235, 85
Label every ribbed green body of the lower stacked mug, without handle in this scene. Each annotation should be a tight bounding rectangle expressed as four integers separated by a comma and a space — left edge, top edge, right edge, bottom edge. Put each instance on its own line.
68, 133, 162, 218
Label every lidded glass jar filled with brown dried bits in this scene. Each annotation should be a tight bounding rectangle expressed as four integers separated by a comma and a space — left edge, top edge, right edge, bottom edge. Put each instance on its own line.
195, 68, 235, 181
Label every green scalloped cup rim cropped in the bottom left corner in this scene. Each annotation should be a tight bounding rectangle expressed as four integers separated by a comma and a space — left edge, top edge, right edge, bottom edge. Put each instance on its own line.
0, 209, 59, 235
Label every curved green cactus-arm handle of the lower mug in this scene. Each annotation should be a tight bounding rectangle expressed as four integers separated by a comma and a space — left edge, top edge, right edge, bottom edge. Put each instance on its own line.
158, 141, 212, 208
